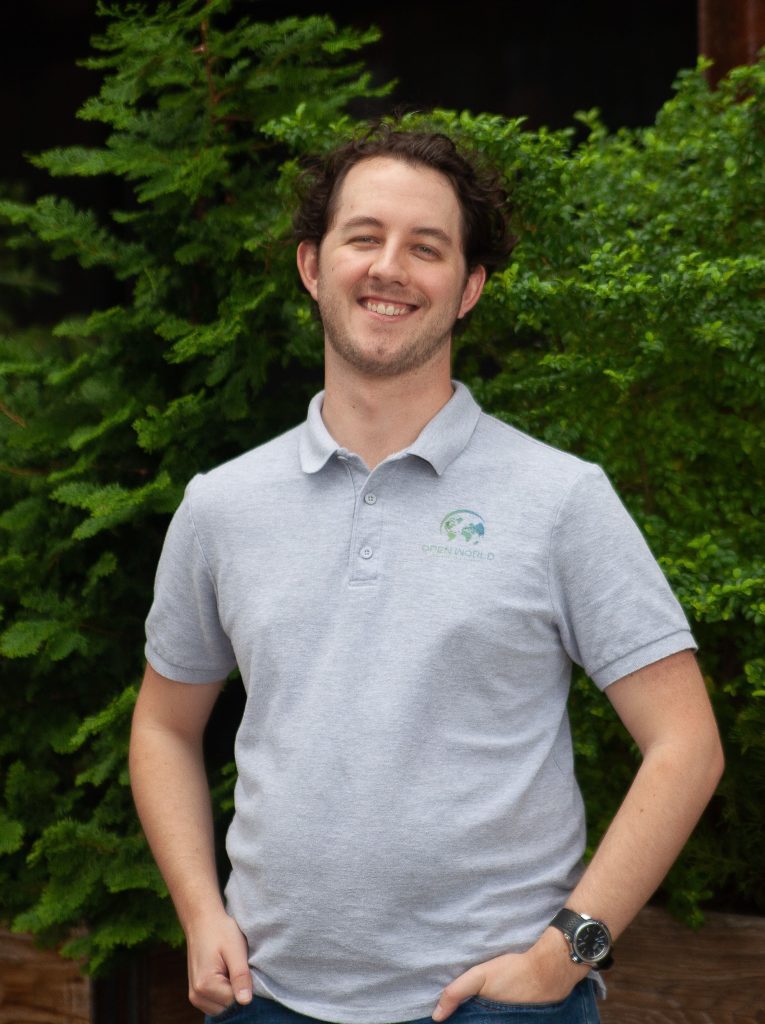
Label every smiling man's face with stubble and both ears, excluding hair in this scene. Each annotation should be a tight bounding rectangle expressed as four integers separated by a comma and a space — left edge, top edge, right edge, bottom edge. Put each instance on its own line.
298, 157, 485, 377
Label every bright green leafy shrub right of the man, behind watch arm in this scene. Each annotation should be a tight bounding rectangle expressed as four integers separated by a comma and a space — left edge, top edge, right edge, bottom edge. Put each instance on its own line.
448, 61, 765, 922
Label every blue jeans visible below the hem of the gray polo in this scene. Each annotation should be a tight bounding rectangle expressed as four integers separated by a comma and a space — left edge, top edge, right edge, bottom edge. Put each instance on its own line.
205, 978, 600, 1024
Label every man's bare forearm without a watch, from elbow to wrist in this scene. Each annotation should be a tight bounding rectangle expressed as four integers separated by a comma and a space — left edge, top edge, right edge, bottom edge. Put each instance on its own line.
130, 714, 223, 933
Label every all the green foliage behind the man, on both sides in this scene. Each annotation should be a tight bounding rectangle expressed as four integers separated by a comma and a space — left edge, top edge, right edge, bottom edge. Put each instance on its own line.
0, 0, 765, 970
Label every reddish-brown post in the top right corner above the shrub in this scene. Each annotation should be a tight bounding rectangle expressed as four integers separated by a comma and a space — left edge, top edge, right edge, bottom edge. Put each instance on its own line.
698, 0, 765, 85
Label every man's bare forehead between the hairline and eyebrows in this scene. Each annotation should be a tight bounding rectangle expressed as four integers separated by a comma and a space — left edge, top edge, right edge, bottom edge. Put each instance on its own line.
328, 157, 462, 240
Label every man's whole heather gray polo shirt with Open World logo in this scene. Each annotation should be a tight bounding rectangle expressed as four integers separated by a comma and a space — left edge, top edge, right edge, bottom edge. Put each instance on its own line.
146, 385, 694, 1024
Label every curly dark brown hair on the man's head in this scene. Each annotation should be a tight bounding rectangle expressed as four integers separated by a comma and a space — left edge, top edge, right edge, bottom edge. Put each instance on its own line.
293, 124, 515, 274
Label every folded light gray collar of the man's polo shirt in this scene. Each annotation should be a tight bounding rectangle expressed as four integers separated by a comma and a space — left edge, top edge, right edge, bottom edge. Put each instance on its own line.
299, 381, 480, 476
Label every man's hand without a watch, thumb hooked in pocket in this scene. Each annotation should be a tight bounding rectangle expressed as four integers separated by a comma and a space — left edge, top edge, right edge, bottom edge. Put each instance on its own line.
186, 912, 252, 1014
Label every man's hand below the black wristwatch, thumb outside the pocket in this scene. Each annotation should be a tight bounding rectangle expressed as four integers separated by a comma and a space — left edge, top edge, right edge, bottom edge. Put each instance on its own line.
433, 929, 590, 1021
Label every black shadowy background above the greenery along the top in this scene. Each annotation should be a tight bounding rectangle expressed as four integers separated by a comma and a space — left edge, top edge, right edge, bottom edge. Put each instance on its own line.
5, 0, 697, 187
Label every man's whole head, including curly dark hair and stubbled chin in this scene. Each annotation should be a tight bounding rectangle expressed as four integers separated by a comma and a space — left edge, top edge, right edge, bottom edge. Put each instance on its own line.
296, 128, 509, 379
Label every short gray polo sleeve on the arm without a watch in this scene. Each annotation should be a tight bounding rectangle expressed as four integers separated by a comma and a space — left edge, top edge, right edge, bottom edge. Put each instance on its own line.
145, 480, 237, 683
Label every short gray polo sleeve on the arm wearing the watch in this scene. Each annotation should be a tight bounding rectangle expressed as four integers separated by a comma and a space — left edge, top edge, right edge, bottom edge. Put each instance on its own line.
549, 466, 696, 688
